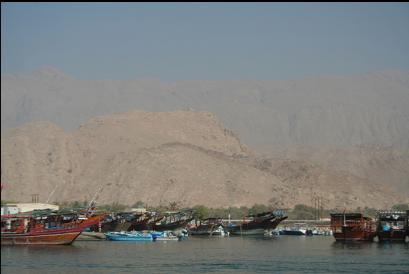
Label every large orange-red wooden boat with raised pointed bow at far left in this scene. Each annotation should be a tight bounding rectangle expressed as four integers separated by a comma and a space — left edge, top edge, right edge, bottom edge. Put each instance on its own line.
1, 210, 102, 245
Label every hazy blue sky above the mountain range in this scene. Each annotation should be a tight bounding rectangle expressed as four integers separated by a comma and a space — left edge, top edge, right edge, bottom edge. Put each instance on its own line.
1, 3, 409, 80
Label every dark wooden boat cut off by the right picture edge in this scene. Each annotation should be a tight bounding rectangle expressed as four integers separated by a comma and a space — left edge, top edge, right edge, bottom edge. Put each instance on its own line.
376, 211, 407, 242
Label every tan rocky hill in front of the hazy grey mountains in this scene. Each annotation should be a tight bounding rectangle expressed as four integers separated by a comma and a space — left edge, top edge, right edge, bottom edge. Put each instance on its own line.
1, 111, 405, 208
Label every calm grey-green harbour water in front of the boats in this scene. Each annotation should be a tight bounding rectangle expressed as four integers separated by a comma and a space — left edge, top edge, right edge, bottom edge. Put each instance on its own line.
1, 236, 409, 274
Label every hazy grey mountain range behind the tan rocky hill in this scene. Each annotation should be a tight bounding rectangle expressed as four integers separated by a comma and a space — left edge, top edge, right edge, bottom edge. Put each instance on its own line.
1, 68, 409, 154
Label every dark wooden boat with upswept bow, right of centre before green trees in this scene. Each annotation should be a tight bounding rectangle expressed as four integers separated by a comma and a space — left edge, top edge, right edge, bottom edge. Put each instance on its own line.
227, 212, 287, 235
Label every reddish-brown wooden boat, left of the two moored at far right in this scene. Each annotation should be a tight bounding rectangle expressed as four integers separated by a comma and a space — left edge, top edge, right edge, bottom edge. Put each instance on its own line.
331, 213, 376, 241
